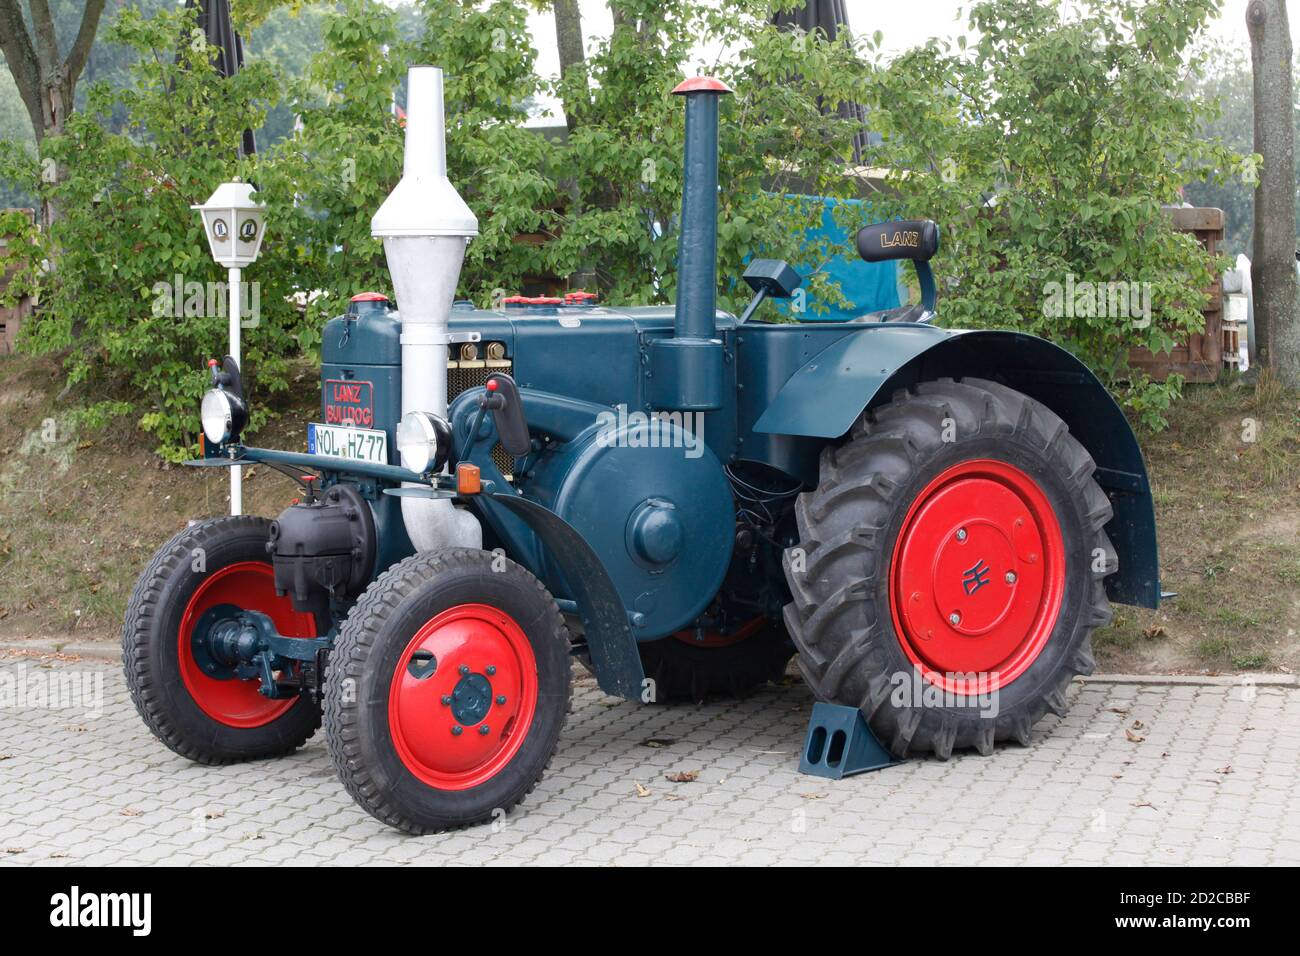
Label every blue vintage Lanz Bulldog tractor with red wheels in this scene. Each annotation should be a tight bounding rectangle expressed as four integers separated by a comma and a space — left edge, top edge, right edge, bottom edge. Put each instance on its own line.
124, 68, 1160, 832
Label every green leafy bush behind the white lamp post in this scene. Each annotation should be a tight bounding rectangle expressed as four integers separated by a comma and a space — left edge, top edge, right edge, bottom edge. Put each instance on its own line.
3, 9, 305, 457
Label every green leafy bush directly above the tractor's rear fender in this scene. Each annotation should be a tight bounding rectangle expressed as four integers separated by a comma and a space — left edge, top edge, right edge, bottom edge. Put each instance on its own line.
866, 0, 1244, 427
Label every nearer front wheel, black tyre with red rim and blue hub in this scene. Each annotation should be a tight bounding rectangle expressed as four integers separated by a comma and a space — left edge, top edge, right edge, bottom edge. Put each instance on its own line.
325, 549, 572, 834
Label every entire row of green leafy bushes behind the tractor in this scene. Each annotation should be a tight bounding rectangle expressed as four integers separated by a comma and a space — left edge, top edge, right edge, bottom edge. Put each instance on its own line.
0, 0, 1235, 458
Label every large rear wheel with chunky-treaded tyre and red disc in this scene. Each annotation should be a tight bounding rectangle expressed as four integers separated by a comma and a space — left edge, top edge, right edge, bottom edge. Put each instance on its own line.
785, 378, 1117, 758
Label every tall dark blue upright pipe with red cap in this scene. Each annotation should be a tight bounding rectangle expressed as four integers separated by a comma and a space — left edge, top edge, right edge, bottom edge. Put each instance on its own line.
650, 77, 731, 411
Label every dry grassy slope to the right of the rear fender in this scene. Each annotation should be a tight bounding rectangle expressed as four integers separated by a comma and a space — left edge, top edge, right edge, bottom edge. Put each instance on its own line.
1095, 376, 1300, 672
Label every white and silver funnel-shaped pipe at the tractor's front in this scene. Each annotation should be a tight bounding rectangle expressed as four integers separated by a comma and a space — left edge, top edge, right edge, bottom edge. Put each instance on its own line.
371, 66, 482, 551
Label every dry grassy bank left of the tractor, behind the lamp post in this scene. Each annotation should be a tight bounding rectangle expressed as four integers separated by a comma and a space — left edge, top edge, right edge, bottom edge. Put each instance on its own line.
0, 355, 319, 637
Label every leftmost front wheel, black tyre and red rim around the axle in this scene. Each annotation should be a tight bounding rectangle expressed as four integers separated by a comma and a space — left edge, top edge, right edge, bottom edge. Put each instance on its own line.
122, 516, 321, 763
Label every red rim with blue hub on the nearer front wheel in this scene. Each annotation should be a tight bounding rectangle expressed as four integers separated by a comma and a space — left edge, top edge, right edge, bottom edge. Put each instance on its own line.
389, 604, 537, 790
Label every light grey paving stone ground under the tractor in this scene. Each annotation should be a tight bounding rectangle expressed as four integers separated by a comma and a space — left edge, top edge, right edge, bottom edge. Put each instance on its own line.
0, 657, 1300, 865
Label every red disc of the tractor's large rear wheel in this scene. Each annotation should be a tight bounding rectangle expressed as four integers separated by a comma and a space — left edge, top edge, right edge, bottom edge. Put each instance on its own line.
889, 459, 1065, 695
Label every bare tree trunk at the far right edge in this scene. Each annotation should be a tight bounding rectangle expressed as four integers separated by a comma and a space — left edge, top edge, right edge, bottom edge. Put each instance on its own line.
1245, 0, 1300, 386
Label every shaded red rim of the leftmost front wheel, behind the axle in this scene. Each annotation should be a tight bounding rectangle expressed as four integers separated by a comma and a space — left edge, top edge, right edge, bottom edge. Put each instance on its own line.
179, 561, 316, 728
